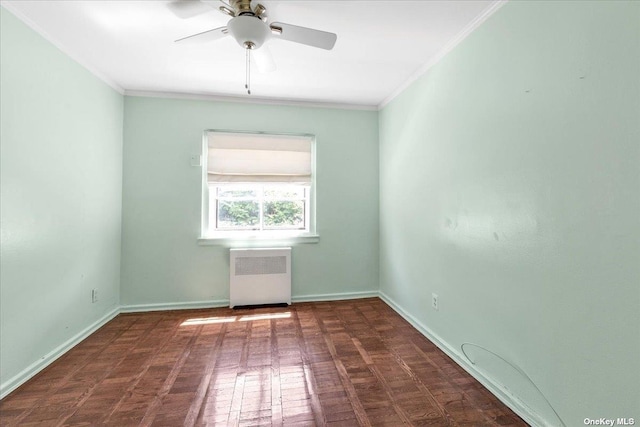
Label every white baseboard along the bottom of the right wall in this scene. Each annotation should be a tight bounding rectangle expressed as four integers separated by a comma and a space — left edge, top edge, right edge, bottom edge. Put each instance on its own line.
378, 291, 550, 427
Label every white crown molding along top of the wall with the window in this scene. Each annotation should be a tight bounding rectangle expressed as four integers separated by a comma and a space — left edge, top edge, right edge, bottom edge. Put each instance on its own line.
124, 90, 378, 111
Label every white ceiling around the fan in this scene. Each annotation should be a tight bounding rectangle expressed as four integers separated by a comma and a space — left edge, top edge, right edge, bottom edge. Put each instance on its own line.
2, 0, 503, 107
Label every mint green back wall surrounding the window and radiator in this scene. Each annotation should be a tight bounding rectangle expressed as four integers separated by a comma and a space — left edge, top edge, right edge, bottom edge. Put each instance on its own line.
121, 96, 378, 306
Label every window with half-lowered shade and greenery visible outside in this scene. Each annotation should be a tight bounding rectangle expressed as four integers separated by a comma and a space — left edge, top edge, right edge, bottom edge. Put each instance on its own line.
202, 131, 315, 239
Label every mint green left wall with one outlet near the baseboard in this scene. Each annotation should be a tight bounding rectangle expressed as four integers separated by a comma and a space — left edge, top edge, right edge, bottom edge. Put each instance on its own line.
0, 8, 123, 391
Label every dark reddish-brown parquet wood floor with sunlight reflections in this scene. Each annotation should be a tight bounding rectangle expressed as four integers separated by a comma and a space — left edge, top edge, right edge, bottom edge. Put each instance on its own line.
0, 298, 526, 427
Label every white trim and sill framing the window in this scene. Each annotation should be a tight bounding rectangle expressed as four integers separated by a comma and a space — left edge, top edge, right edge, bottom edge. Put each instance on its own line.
198, 129, 320, 247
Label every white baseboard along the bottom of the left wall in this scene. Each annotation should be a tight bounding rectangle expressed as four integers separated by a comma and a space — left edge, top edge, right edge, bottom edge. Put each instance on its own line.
0, 307, 120, 399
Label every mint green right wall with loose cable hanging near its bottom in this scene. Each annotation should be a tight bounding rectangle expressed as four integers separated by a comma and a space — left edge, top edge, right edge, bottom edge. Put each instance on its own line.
380, 1, 640, 426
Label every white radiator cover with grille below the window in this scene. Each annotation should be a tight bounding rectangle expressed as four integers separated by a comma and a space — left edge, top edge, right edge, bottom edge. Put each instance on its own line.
229, 248, 291, 307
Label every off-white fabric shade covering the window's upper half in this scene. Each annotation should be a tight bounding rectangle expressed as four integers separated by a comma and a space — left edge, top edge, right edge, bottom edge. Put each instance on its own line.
207, 132, 311, 184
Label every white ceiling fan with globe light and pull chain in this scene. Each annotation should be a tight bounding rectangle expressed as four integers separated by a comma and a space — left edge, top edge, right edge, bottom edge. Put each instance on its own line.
168, 0, 338, 94
